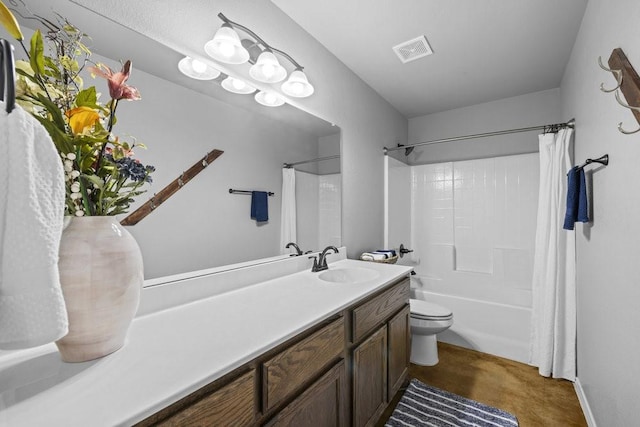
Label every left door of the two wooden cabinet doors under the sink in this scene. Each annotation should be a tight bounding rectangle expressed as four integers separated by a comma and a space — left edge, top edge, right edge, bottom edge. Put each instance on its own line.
353, 325, 387, 427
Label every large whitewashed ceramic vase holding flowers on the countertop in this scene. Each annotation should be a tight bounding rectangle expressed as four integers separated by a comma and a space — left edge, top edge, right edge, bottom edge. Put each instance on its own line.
56, 216, 144, 362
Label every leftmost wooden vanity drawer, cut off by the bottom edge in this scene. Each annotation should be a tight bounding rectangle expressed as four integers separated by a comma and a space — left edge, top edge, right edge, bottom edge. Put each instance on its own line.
152, 369, 256, 426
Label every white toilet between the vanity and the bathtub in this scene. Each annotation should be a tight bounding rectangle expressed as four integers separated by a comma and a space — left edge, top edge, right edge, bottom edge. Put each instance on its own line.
409, 299, 453, 366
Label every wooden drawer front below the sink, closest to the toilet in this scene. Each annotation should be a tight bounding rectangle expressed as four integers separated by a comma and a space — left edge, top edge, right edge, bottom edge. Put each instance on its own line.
352, 278, 409, 343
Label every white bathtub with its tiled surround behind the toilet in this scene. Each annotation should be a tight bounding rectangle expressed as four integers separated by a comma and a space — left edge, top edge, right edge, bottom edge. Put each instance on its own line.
390, 153, 539, 363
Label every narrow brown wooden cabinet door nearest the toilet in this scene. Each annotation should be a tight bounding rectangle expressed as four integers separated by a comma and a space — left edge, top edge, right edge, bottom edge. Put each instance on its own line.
388, 306, 411, 399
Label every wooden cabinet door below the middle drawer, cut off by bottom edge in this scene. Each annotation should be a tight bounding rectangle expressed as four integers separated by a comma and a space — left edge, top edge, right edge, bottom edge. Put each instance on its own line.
267, 360, 347, 427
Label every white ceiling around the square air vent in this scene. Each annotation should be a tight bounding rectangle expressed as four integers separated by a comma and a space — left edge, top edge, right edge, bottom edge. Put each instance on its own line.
271, 0, 587, 118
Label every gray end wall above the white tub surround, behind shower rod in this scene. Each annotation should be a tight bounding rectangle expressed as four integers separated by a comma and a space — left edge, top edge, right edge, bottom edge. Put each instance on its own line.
410, 89, 560, 164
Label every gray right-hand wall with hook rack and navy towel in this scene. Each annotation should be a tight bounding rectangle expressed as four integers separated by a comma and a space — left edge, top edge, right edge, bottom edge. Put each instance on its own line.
560, 0, 640, 427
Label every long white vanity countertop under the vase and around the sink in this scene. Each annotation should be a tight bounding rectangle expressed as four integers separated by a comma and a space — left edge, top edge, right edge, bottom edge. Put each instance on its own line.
0, 260, 411, 427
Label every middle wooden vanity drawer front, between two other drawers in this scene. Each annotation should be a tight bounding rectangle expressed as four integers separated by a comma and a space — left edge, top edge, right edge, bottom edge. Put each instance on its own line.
262, 317, 344, 412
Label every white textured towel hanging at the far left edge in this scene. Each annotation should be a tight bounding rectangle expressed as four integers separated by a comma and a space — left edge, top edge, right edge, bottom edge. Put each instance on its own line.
0, 102, 68, 350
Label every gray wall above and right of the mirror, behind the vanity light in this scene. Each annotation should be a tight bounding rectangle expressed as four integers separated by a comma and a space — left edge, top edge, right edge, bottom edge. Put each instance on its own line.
77, 0, 407, 257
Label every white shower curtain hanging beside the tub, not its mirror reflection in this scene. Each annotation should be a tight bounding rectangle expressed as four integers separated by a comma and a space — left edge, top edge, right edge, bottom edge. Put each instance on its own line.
529, 129, 576, 381
